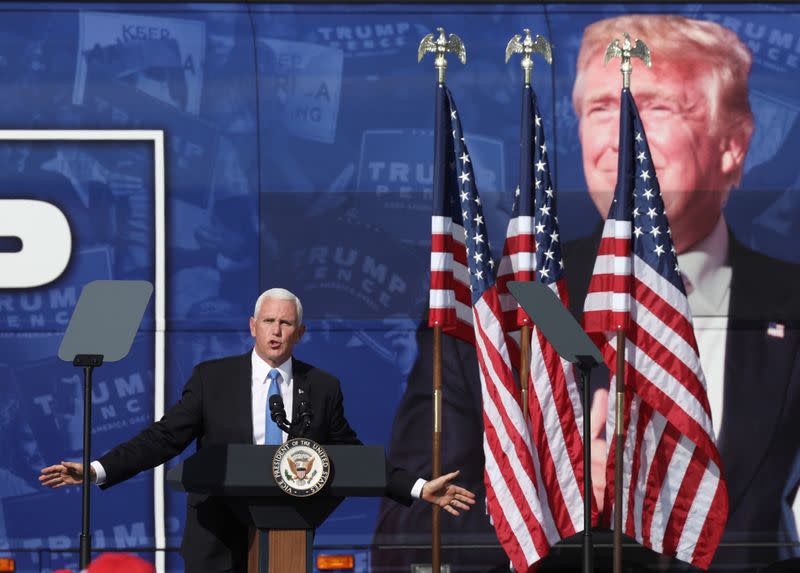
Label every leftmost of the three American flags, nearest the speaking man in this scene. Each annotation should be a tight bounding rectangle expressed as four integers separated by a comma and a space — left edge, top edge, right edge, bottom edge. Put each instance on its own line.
431, 85, 560, 572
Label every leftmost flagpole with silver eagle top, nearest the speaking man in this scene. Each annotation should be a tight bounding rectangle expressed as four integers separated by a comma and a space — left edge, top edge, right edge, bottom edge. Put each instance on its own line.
417, 28, 467, 573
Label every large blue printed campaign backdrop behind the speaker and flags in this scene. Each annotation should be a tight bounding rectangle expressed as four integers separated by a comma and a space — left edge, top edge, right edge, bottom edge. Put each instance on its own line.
0, 2, 800, 571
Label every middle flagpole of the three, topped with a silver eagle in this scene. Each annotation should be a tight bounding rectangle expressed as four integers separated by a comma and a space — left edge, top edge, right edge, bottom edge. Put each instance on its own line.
506, 28, 553, 421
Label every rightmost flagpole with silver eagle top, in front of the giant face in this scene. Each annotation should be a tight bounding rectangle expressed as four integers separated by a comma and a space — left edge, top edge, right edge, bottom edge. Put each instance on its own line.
604, 32, 651, 573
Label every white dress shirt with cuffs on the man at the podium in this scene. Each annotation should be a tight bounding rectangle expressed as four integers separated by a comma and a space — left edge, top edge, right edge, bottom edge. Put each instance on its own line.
91, 348, 427, 499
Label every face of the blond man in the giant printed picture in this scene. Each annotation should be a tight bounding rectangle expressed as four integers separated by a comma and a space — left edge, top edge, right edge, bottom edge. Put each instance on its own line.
576, 54, 737, 251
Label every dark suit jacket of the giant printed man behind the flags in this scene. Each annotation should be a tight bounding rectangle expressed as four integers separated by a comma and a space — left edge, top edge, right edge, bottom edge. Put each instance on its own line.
375, 232, 800, 571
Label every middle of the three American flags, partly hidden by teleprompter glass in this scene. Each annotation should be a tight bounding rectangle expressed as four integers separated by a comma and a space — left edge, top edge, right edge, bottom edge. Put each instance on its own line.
497, 85, 583, 537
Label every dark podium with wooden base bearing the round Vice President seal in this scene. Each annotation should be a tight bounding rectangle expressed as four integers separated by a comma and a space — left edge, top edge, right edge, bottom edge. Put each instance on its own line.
167, 444, 386, 573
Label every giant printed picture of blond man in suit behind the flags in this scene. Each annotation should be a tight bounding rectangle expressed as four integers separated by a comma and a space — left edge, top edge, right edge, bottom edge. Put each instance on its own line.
375, 14, 800, 570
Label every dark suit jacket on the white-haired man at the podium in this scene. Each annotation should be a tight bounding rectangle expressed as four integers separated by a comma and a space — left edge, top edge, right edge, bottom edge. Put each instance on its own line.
99, 352, 414, 573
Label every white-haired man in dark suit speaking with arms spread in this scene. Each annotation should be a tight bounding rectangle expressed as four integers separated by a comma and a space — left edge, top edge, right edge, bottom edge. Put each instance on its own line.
39, 288, 474, 573
